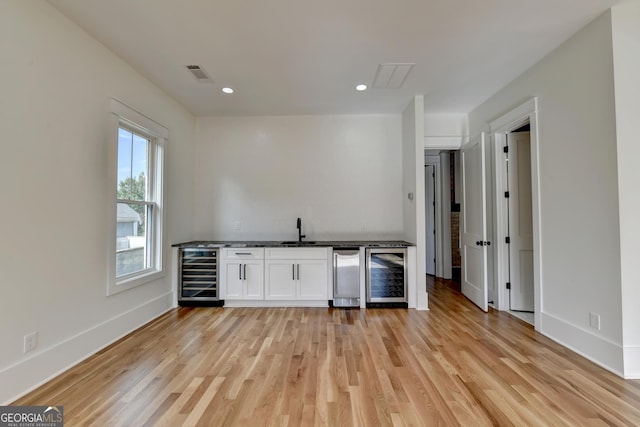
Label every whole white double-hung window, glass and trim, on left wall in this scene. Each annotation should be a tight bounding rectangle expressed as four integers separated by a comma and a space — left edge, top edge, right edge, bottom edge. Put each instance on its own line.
107, 100, 168, 295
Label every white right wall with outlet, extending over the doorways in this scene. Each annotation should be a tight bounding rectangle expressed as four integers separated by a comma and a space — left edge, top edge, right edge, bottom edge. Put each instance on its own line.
469, 13, 622, 373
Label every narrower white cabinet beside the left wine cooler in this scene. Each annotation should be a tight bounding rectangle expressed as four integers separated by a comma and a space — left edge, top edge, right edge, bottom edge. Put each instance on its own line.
222, 248, 264, 300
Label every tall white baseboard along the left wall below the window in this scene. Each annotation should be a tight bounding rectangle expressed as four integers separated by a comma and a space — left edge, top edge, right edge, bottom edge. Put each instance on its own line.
0, 292, 174, 405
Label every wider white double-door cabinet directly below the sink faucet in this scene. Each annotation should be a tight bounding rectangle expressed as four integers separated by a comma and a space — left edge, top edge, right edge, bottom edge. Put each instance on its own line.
265, 248, 329, 301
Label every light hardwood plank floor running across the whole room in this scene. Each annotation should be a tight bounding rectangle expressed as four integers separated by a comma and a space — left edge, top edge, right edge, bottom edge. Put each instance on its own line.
15, 280, 640, 426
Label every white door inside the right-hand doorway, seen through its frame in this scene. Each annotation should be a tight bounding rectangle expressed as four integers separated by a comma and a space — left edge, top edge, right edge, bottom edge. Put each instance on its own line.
507, 132, 534, 311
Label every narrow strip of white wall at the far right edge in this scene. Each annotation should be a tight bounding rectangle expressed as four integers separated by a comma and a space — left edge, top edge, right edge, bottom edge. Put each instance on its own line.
612, 1, 640, 378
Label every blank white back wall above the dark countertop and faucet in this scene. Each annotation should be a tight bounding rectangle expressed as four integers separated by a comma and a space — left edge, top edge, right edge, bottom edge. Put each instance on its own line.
194, 115, 402, 240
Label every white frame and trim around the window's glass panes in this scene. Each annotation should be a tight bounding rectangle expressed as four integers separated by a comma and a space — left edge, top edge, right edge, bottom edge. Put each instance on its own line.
107, 99, 169, 295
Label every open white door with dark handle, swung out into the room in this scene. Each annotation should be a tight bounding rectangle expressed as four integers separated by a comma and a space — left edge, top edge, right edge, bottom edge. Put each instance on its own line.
460, 133, 490, 311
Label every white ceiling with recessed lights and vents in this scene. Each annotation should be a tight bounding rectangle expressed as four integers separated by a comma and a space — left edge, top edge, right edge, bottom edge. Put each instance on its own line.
49, 0, 619, 116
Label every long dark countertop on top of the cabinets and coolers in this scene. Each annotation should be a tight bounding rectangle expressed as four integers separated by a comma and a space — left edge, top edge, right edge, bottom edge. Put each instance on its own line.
171, 240, 414, 248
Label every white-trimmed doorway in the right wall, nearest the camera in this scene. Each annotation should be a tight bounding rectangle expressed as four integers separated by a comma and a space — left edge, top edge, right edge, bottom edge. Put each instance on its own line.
490, 98, 543, 329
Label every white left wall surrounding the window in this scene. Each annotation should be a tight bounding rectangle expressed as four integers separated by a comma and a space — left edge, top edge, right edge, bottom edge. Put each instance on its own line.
0, 1, 195, 403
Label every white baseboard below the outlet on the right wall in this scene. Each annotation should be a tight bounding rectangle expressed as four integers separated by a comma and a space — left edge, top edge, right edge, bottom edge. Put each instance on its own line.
536, 313, 624, 377
